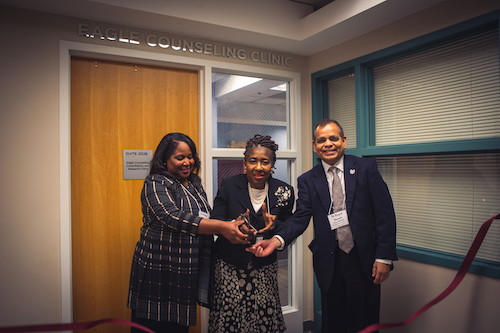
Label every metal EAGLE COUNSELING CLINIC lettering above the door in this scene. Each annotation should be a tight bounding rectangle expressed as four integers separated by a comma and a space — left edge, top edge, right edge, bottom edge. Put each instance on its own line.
78, 23, 292, 67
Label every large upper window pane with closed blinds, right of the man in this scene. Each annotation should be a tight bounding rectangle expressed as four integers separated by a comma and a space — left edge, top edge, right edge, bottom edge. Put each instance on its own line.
373, 28, 500, 146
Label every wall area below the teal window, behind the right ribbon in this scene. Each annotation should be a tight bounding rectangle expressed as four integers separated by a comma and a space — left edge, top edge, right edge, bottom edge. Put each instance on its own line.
381, 258, 500, 333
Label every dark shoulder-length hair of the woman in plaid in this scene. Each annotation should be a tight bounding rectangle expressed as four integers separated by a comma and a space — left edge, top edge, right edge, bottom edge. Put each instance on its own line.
149, 133, 201, 180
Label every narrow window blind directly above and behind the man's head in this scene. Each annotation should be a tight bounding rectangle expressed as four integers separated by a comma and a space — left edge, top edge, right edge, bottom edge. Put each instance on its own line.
328, 73, 357, 148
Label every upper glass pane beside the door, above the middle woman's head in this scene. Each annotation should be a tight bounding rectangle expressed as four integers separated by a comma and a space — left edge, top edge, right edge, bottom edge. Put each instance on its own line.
212, 73, 290, 149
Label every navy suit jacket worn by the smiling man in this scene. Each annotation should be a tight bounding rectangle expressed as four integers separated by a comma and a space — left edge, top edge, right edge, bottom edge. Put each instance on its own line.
278, 155, 397, 291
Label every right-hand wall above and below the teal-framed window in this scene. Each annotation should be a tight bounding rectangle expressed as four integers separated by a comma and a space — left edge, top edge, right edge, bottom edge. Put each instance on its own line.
302, 0, 500, 333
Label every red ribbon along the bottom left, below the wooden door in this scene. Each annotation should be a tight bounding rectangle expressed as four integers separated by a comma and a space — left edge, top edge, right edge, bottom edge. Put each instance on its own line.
0, 318, 155, 333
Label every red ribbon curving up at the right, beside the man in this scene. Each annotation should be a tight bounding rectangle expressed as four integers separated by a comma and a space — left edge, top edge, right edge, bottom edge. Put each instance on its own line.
358, 214, 500, 333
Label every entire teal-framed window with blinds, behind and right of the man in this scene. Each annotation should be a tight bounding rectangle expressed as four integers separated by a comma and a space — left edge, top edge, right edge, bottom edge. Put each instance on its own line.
312, 12, 500, 278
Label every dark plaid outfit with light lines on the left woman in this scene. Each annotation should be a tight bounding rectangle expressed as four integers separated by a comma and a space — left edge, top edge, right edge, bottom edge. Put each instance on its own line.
127, 174, 213, 326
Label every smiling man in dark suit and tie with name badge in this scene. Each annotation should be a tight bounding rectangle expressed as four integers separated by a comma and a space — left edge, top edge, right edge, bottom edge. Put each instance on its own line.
248, 119, 397, 333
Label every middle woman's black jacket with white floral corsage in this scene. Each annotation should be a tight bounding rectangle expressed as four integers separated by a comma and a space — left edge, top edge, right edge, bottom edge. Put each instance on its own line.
210, 174, 295, 269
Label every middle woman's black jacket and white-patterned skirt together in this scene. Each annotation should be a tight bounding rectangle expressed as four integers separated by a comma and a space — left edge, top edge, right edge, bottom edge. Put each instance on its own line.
208, 174, 295, 333
